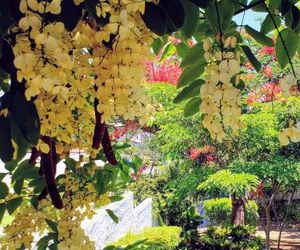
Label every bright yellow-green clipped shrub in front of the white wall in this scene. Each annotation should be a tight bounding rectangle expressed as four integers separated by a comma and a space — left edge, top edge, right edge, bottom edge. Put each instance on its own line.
107, 227, 181, 250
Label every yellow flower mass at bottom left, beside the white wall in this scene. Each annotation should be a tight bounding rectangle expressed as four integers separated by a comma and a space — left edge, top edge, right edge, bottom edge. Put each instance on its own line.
0, 157, 115, 250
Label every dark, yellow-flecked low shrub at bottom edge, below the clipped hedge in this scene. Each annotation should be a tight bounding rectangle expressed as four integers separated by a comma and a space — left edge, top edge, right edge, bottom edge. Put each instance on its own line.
199, 225, 263, 250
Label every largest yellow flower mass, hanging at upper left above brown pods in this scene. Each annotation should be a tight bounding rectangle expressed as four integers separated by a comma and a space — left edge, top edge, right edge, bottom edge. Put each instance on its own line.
13, 0, 153, 153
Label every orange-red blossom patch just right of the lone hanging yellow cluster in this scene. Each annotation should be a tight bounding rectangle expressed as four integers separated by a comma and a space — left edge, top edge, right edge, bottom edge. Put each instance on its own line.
247, 82, 282, 105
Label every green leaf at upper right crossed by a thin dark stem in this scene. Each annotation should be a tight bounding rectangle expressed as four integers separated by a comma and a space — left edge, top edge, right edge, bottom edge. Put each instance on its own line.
275, 28, 299, 68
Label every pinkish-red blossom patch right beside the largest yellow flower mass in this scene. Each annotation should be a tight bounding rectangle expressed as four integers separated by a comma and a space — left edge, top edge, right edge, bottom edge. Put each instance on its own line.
145, 59, 182, 85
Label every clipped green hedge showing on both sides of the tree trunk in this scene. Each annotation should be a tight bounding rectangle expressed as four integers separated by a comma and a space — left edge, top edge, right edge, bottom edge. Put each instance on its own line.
203, 198, 258, 226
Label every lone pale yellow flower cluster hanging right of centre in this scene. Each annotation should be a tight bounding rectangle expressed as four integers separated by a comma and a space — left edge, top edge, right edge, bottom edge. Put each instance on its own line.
200, 37, 242, 142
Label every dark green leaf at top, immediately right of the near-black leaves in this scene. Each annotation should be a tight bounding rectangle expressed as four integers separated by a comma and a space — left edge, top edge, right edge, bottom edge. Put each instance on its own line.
182, 1, 199, 38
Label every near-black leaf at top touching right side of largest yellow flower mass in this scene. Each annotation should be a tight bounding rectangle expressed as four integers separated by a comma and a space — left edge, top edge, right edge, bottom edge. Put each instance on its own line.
142, 2, 167, 36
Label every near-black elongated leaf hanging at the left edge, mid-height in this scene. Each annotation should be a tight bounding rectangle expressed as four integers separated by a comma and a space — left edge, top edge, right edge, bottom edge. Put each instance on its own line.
0, 115, 15, 163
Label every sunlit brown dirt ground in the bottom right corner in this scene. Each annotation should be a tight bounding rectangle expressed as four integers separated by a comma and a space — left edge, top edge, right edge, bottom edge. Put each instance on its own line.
256, 230, 300, 250
